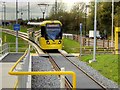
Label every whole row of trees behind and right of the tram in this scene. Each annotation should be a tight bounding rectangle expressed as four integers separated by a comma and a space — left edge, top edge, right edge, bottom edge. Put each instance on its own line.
48, 1, 120, 36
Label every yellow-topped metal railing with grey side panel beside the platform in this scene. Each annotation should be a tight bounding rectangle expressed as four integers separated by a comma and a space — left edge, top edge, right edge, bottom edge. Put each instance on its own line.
9, 46, 76, 89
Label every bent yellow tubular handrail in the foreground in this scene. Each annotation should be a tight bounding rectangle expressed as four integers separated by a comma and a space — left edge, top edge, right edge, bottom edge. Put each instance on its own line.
8, 50, 76, 90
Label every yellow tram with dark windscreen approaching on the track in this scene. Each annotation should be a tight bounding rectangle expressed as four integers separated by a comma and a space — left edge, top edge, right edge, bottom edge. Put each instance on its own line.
29, 20, 63, 50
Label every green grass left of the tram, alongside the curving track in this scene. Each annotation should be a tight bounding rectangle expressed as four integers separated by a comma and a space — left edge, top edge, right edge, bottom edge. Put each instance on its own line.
2, 25, 40, 52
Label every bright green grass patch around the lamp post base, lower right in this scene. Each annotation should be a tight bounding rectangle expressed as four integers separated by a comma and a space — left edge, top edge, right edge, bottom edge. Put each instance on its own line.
81, 54, 118, 82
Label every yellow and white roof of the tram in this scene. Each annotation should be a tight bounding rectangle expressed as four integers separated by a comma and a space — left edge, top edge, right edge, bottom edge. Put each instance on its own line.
27, 20, 62, 26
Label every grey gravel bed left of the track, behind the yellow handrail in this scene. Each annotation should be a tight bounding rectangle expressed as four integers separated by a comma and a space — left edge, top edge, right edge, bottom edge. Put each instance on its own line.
31, 56, 60, 89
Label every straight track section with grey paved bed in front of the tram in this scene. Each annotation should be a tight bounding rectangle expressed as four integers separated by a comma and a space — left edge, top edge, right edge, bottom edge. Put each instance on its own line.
47, 50, 106, 90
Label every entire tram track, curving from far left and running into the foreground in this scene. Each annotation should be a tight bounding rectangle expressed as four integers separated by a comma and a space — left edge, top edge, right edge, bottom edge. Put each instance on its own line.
2, 29, 109, 89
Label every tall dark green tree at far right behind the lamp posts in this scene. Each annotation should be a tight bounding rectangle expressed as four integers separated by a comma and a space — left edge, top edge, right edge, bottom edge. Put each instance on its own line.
88, 2, 120, 36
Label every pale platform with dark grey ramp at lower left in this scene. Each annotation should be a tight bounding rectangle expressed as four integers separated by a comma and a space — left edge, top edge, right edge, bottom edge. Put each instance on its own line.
0, 53, 23, 89
